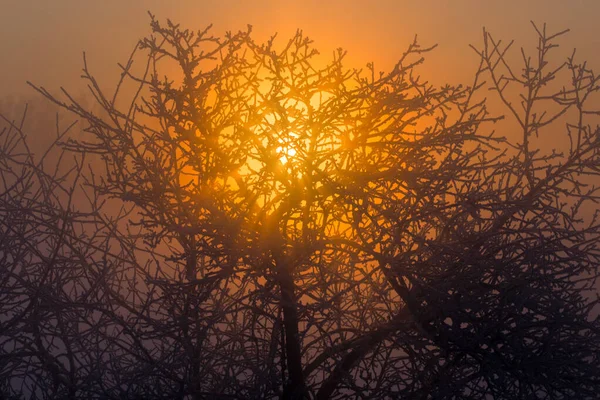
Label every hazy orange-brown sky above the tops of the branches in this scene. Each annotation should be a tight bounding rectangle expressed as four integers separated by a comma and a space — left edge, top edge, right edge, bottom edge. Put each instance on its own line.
0, 0, 600, 97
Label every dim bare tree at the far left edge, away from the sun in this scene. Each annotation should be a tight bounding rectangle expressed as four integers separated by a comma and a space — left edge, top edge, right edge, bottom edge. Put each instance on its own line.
0, 104, 125, 398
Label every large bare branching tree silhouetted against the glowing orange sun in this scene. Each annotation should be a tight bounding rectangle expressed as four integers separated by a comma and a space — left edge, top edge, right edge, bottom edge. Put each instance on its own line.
3, 17, 600, 399
